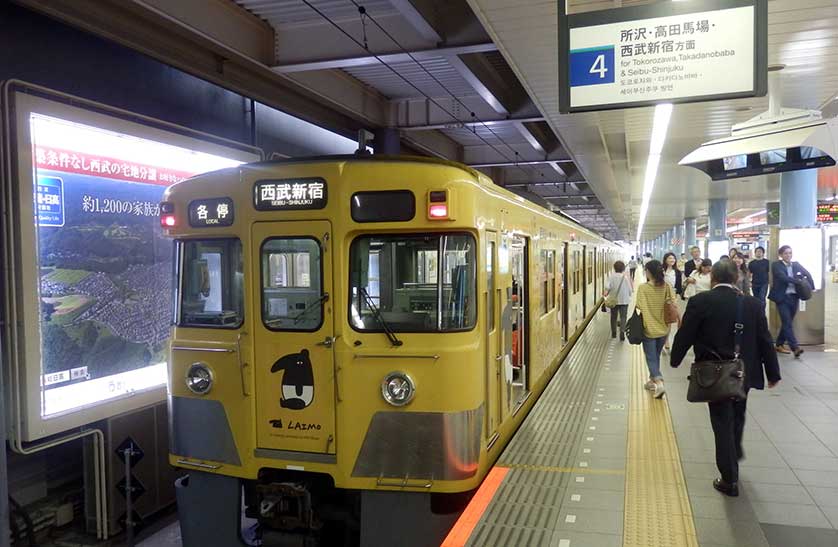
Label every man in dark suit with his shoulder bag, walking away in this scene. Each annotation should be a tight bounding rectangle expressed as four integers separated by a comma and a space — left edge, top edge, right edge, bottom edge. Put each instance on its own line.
670, 260, 780, 496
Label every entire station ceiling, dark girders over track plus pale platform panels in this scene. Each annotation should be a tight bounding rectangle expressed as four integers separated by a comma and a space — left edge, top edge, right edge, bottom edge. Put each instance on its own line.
15, 0, 838, 244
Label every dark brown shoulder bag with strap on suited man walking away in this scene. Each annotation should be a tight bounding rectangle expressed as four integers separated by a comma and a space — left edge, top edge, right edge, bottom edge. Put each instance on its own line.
687, 295, 747, 403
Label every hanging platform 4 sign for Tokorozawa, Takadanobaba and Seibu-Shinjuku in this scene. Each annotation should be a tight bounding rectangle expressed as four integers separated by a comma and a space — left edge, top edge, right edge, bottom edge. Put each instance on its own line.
559, 0, 768, 113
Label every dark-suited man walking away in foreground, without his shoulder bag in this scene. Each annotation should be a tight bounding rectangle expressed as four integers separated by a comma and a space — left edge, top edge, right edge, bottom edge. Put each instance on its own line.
670, 260, 780, 496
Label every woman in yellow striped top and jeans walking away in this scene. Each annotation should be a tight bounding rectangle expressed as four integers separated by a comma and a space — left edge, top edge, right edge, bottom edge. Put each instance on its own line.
635, 260, 675, 398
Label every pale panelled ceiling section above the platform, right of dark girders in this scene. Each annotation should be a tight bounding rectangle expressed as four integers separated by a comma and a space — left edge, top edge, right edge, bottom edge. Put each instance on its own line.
468, 0, 838, 239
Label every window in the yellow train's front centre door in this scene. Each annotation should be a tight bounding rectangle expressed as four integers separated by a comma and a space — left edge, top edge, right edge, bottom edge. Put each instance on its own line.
262, 237, 326, 331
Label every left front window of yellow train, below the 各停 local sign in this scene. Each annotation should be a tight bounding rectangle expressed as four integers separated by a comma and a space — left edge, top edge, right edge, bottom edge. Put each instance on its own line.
177, 239, 244, 328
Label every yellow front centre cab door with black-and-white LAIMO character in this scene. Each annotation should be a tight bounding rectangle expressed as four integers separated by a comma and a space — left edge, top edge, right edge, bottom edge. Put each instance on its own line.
250, 221, 335, 459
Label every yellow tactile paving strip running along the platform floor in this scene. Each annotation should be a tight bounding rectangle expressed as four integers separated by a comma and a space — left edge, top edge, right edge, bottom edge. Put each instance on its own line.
623, 346, 698, 547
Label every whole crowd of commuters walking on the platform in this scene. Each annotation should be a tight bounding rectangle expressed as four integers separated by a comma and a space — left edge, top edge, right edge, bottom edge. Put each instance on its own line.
605, 245, 814, 496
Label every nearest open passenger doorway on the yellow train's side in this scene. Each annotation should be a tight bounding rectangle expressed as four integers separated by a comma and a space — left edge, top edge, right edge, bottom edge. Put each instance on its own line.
509, 236, 530, 404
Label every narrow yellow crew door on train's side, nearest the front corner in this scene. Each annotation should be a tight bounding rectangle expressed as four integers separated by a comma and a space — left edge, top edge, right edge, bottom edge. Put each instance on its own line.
483, 231, 504, 438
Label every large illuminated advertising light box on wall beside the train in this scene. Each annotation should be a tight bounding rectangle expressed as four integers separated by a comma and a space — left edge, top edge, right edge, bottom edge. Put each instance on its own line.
4, 85, 261, 441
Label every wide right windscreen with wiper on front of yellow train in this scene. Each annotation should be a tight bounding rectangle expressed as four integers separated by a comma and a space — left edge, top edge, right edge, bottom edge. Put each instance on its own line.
349, 234, 477, 332
